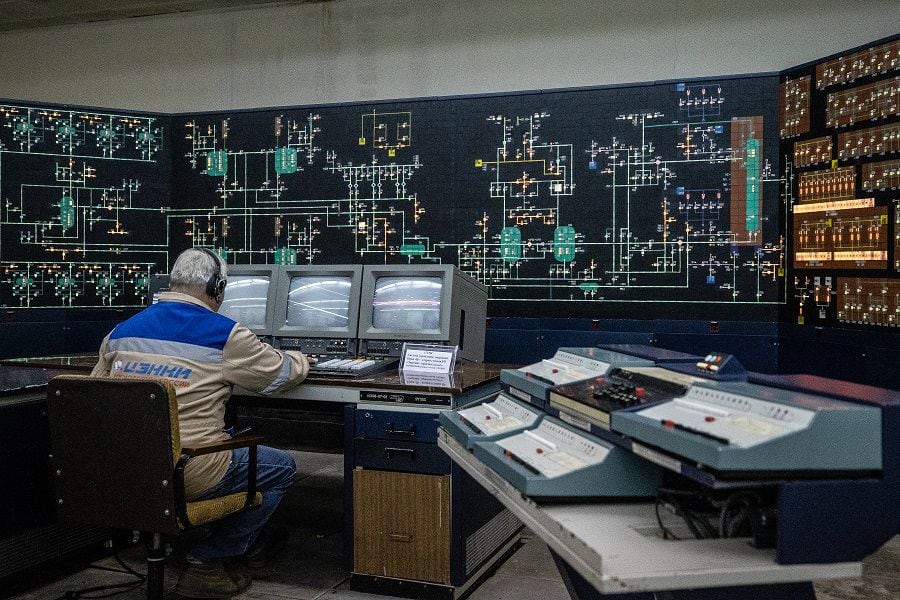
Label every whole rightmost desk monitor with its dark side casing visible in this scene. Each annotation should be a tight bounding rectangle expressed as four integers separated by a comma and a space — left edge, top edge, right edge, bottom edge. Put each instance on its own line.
359, 265, 488, 362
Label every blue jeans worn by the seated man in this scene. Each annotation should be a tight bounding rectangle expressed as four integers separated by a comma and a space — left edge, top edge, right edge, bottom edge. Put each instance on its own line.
190, 446, 297, 562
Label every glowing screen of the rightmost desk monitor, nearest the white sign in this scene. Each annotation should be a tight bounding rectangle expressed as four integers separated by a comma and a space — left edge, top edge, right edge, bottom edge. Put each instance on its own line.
372, 276, 444, 331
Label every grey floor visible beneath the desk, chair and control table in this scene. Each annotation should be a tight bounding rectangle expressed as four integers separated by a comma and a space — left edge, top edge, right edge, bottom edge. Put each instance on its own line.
12, 452, 900, 600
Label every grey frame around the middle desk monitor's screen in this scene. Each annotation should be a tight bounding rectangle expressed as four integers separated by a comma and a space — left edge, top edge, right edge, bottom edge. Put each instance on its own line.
272, 265, 363, 339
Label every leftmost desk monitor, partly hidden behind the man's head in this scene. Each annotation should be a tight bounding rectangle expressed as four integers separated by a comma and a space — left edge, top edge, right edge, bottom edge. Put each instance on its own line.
219, 265, 281, 337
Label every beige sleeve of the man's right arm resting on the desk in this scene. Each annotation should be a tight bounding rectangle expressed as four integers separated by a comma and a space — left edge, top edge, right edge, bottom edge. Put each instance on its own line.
223, 324, 309, 396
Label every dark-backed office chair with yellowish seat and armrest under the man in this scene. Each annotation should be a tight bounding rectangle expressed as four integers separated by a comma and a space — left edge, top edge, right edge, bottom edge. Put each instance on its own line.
47, 375, 262, 600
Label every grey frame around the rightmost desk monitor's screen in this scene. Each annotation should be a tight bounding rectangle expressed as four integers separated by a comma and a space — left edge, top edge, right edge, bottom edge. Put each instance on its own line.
359, 264, 455, 342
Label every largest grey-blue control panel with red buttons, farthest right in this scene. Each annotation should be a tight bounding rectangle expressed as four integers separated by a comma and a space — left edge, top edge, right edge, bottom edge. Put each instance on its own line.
611, 382, 881, 475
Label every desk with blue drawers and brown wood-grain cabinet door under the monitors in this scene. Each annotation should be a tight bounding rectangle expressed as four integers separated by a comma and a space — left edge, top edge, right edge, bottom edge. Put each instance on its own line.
0, 354, 522, 598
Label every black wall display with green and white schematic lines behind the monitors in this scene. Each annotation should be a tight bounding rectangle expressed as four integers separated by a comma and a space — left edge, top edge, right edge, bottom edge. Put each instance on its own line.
0, 76, 787, 321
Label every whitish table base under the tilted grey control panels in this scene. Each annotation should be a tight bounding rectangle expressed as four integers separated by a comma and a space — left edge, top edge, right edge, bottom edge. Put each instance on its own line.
438, 430, 862, 594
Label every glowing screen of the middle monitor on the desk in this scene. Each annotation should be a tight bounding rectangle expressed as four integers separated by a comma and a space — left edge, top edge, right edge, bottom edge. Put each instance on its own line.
284, 275, 353, 329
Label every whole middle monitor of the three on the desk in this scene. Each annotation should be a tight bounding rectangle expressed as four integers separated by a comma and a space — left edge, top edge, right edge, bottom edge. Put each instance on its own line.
272, 265, 363, 356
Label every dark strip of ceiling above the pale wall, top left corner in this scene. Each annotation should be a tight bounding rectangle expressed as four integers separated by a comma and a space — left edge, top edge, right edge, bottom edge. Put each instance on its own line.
0, 0, 332, 31
